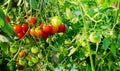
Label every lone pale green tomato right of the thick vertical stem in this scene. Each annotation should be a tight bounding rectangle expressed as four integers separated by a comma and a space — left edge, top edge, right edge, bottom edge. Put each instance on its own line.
89, 32, 101, 43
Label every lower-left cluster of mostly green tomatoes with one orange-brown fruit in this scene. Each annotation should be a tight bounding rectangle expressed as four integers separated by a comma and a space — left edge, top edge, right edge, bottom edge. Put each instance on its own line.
16, 46, 39, 70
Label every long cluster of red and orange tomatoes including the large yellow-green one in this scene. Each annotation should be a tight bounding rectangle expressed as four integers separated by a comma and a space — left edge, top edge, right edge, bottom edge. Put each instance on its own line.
13, 16, 66, 39
